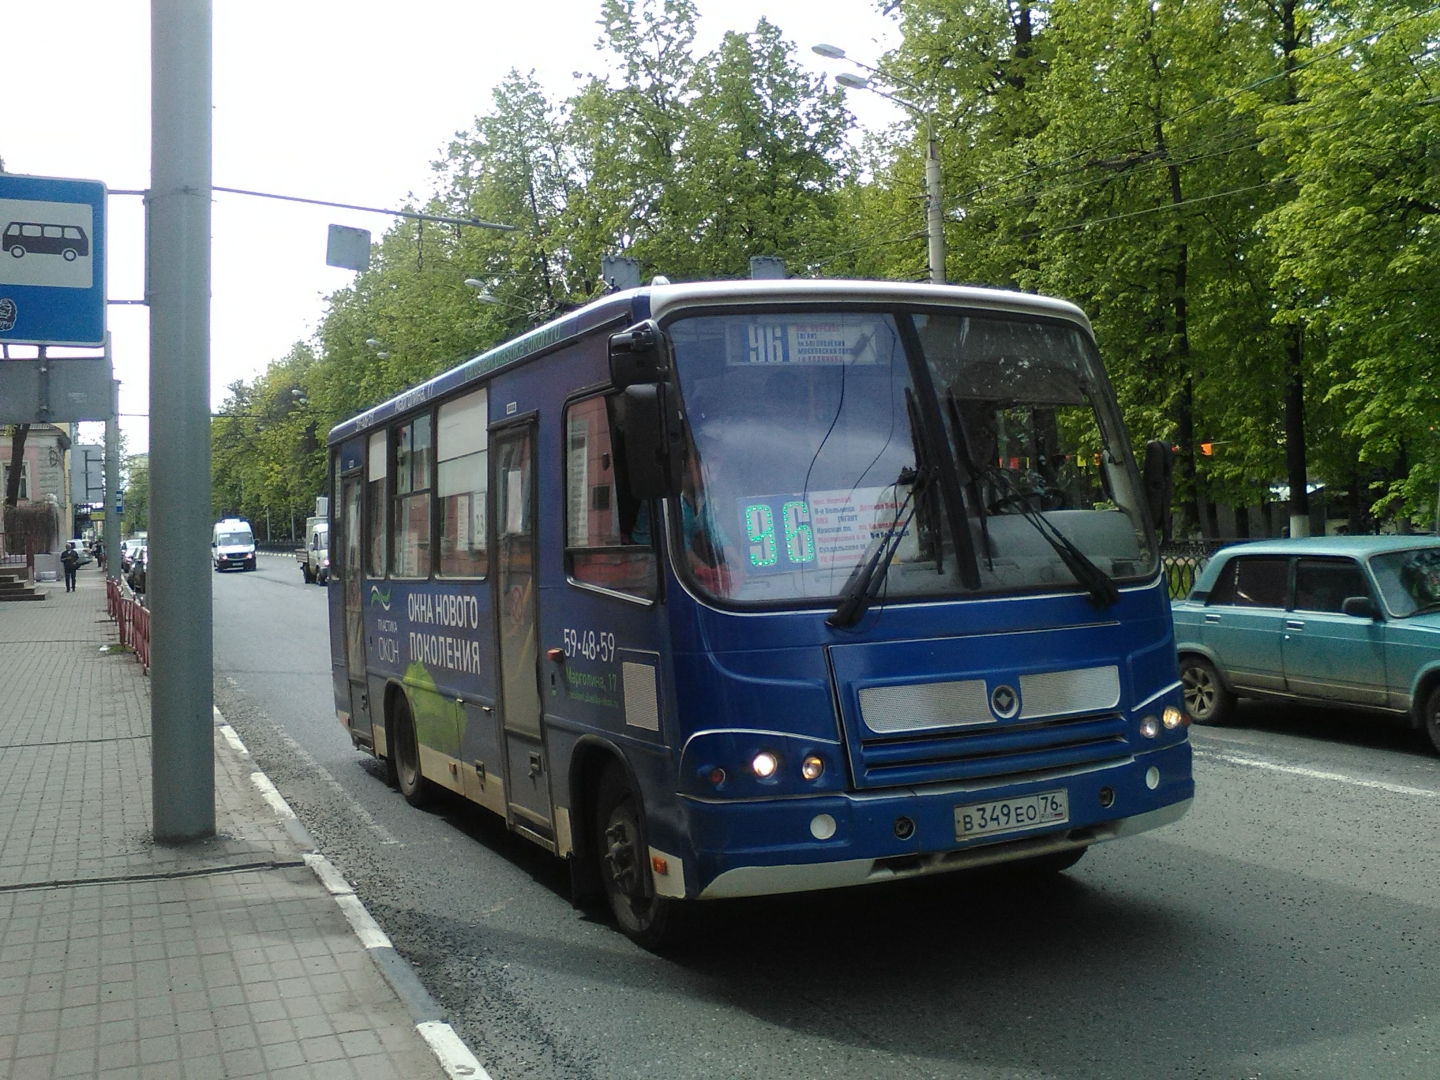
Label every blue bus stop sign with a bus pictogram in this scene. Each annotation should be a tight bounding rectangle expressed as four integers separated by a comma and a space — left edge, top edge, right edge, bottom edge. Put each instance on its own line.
0, 173, 107, 346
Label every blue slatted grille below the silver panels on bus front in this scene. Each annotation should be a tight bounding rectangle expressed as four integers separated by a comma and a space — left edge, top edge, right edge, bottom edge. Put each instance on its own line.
854, 713, 1130, 788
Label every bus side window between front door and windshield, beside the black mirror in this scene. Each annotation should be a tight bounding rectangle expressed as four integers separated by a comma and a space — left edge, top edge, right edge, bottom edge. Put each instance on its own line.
564, 395, 657, 599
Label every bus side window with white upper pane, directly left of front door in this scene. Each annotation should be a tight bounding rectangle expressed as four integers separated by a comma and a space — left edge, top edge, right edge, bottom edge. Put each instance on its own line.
435, 390, 490, 577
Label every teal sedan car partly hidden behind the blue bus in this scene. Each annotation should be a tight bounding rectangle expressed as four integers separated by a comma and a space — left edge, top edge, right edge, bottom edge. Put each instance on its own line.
1172, 536, 1440, 750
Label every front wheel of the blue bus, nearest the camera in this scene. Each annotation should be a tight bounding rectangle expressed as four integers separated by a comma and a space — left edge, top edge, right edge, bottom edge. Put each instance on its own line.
595, 766, 684, 952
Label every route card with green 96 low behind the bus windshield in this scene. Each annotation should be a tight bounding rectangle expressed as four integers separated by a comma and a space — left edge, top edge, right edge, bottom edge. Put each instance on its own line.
739, 485, 913, 573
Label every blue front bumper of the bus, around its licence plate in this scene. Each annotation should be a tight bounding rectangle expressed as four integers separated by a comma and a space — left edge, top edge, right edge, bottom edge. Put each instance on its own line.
685, 742, 1195, 900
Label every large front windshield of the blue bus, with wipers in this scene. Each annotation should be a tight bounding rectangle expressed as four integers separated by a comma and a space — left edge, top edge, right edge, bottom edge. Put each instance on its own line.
668, 308, 1156, 603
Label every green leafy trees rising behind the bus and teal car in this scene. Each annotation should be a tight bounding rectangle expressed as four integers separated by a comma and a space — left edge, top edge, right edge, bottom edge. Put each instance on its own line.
213, 0, 1440, 531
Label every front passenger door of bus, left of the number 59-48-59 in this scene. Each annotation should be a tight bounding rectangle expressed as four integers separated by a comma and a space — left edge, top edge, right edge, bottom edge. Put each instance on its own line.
490, 422, 554, 844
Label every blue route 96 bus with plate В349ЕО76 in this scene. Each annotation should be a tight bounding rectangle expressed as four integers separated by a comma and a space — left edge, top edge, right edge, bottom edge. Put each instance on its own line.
328, 279, 1194, 948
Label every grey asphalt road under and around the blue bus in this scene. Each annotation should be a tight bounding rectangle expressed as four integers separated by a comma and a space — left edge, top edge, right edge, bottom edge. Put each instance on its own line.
215, 554, 1440, 1080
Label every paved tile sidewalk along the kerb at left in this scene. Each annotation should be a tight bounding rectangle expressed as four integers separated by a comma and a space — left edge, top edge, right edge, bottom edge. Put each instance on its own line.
0, 567, 445, 1080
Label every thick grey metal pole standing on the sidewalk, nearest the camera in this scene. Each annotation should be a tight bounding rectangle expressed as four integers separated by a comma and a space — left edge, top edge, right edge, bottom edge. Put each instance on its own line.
145, 0, 215, 844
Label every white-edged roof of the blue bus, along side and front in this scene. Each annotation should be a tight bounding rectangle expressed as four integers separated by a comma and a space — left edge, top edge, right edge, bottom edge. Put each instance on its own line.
330, 278, 1090, 445
